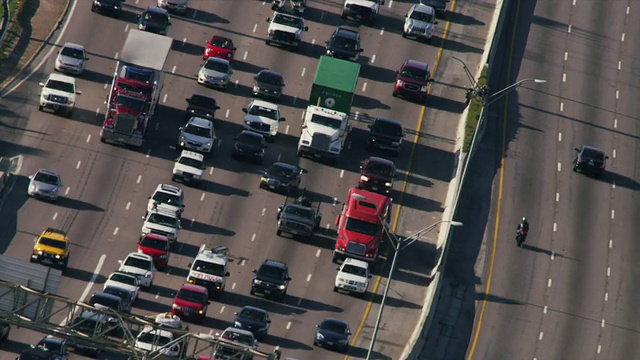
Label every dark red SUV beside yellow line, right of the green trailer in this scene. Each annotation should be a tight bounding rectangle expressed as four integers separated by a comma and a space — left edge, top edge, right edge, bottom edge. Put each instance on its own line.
393, 60, 433, 102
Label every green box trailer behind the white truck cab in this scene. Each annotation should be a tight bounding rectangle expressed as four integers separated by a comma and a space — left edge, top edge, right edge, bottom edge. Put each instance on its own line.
309, 56, 360, 114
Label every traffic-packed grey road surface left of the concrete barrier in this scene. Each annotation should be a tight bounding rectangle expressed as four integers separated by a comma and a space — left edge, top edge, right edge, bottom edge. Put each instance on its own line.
0, 0, 488, 359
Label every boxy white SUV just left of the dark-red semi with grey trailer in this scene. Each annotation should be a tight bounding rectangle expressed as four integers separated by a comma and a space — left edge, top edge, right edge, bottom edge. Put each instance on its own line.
39, 74, 81, 117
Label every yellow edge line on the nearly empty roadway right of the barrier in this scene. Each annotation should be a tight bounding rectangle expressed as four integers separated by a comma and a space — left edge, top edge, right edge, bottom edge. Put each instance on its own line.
467, 0, 520, 360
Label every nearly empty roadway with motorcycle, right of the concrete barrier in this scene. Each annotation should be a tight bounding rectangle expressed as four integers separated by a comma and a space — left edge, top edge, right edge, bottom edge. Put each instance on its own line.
433, 1, 640, 359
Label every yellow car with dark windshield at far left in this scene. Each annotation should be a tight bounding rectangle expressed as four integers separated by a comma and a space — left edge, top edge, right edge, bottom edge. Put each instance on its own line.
30, 228, 70, 270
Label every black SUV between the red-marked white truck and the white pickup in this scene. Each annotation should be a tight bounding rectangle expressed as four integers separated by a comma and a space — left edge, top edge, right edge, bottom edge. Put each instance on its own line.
251, 260, 291, 301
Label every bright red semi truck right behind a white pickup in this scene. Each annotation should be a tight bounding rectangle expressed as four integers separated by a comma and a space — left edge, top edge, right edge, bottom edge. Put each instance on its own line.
333, 187, 391, 262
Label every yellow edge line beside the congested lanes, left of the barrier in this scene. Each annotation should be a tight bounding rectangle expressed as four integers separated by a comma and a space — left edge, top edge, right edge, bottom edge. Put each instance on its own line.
344, 0, 456, 360
